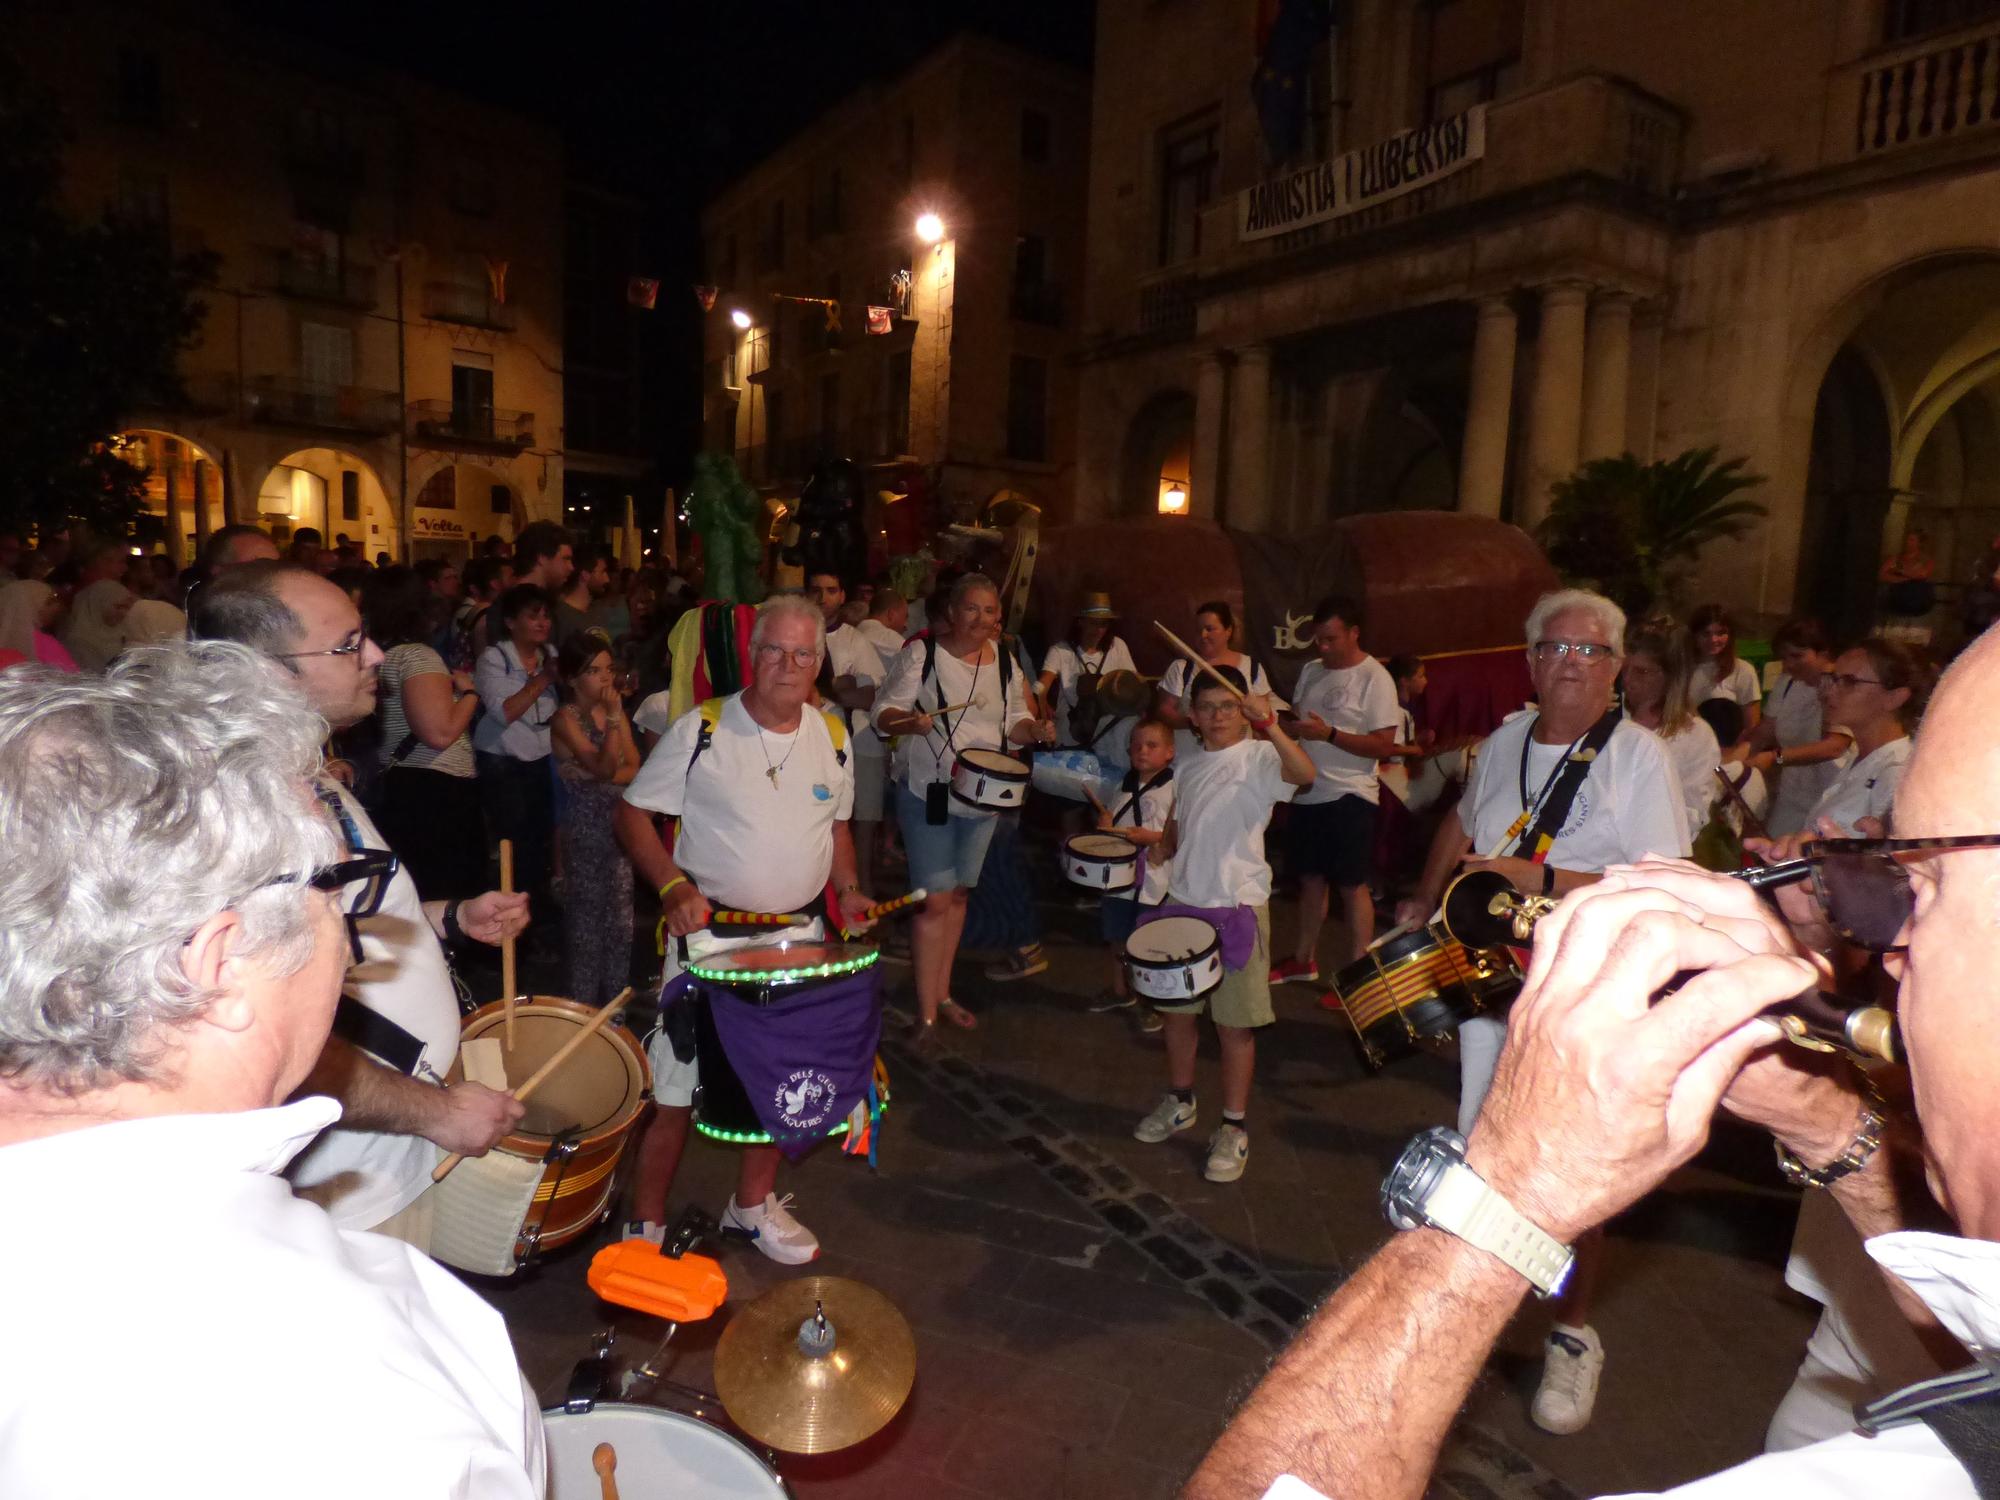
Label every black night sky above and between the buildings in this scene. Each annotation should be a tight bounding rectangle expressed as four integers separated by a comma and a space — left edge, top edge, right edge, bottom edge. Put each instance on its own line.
242, 0, 1092, 496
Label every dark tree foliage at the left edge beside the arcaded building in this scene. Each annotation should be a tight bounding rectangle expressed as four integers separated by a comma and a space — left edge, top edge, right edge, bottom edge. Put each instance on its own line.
0, 66, 214, 536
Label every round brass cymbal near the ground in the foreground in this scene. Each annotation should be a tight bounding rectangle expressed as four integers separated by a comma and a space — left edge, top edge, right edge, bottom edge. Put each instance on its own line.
716, 1276, 916, 1454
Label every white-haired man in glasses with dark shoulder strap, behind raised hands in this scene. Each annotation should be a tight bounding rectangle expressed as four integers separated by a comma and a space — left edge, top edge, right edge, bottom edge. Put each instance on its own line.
1396, 588, 1688, 1432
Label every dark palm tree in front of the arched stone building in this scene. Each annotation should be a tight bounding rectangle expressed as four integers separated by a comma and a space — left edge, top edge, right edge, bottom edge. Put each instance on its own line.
1536, 448, 1768, 618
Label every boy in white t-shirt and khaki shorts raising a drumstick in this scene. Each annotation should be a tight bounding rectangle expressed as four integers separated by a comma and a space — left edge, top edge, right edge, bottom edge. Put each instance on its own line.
1132, 666, 1314, 1182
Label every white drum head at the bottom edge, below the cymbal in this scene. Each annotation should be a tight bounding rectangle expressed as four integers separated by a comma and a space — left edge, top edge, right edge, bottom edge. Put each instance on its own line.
548, 1408, 792, 1500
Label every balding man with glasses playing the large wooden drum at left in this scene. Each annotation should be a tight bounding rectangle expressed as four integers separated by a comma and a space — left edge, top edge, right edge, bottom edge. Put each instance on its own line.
188, 562, 528, 1250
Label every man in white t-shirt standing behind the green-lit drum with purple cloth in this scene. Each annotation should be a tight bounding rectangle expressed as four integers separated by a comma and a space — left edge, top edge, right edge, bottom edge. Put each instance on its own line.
618, 594, 880, 1264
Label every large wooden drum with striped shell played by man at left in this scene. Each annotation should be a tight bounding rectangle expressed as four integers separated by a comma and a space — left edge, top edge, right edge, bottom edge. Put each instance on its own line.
430, 994, 652, 1276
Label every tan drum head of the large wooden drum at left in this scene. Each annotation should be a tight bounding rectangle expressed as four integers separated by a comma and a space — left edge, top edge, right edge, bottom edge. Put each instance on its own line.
460, 996, 646, 1156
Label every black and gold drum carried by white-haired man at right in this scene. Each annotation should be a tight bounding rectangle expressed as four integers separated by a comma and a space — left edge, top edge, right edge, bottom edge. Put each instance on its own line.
1334, 924, 1520, 1068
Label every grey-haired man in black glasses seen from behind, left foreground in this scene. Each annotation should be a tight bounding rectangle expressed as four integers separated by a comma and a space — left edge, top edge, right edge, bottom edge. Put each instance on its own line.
0, 644, 544, 1500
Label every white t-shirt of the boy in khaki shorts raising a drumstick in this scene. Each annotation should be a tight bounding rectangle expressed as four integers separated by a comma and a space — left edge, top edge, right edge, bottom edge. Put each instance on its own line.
1168, 736, 1296, 906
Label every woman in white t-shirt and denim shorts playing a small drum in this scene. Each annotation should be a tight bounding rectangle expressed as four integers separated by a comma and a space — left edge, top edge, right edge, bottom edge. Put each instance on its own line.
874, 572, 1056, 1036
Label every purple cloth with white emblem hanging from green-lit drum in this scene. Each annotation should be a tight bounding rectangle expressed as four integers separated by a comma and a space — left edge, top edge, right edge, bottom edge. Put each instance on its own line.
702, 968, 882, 1160
